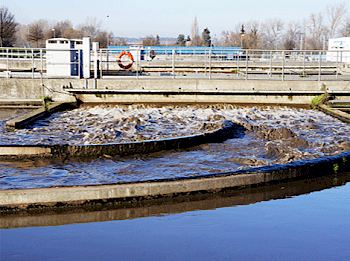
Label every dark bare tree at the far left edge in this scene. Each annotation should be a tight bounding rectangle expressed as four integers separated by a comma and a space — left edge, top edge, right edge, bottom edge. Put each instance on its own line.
0, 7, 17, 47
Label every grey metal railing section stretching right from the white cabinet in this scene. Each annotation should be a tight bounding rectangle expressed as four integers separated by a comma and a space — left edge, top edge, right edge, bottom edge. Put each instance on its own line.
98, 48, 350, 81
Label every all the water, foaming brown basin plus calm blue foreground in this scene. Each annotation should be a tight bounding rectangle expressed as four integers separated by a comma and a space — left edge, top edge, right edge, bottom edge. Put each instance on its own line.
0, 106, 350, 260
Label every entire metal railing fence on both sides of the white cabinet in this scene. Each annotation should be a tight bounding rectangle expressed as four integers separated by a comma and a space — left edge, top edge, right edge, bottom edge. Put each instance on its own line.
0, 47, 350, 81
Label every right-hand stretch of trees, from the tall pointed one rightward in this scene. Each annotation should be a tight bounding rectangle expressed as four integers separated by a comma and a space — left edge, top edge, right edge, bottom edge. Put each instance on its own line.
177, 2, 350, 50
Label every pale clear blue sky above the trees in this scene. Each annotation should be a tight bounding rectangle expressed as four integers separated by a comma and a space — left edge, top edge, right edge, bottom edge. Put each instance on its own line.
0, 0, 349, 37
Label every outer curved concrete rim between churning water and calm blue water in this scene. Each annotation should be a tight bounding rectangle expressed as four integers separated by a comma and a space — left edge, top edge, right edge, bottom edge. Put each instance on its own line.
0, 151, 350, 208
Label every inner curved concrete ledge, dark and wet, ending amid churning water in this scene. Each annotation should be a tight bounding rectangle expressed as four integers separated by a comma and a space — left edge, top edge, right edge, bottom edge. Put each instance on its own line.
0, 121, 239, 158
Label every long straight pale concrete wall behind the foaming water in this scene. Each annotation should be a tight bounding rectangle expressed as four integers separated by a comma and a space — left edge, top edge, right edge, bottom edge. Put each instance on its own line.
0, 78, 350, 104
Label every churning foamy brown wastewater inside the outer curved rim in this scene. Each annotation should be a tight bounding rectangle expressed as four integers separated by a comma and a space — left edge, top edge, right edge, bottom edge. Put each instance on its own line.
0, 105, 350, 189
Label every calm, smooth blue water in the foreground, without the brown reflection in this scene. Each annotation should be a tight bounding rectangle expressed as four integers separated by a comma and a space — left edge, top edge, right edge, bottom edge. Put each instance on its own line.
0, 178, 350, 260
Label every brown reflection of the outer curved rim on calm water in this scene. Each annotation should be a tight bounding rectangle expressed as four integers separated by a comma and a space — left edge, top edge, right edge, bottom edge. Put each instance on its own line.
0, 173, 350, 229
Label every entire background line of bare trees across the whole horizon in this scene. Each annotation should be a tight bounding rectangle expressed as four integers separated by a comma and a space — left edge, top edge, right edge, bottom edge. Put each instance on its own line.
0, 2, 350, 50
